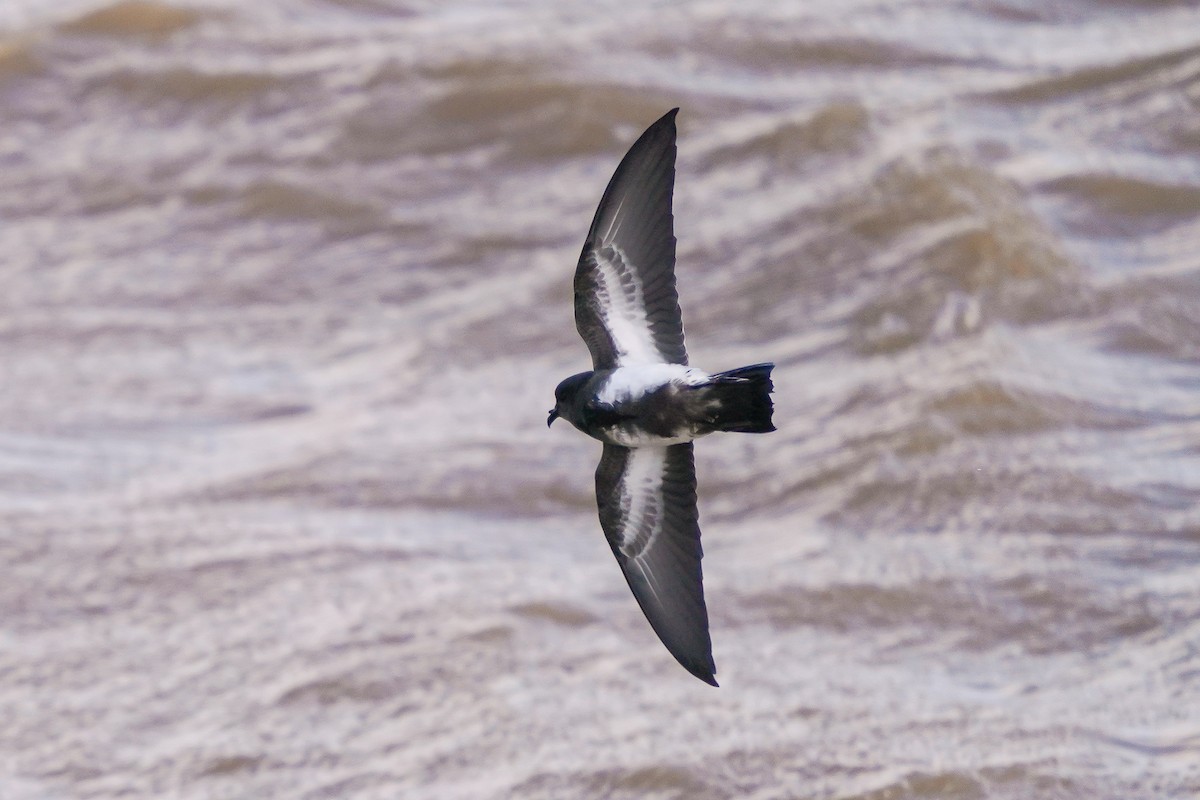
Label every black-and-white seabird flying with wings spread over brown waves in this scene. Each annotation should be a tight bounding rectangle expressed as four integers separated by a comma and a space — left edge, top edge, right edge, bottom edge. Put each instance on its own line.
546, 108, 775, 686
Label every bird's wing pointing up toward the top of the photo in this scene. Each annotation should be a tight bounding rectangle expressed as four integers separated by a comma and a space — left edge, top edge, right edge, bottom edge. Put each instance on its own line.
575, 108, 688, 369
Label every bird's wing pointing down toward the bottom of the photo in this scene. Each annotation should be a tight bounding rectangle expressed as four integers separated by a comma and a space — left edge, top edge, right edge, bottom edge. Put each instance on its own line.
596, 443, 716, 686
